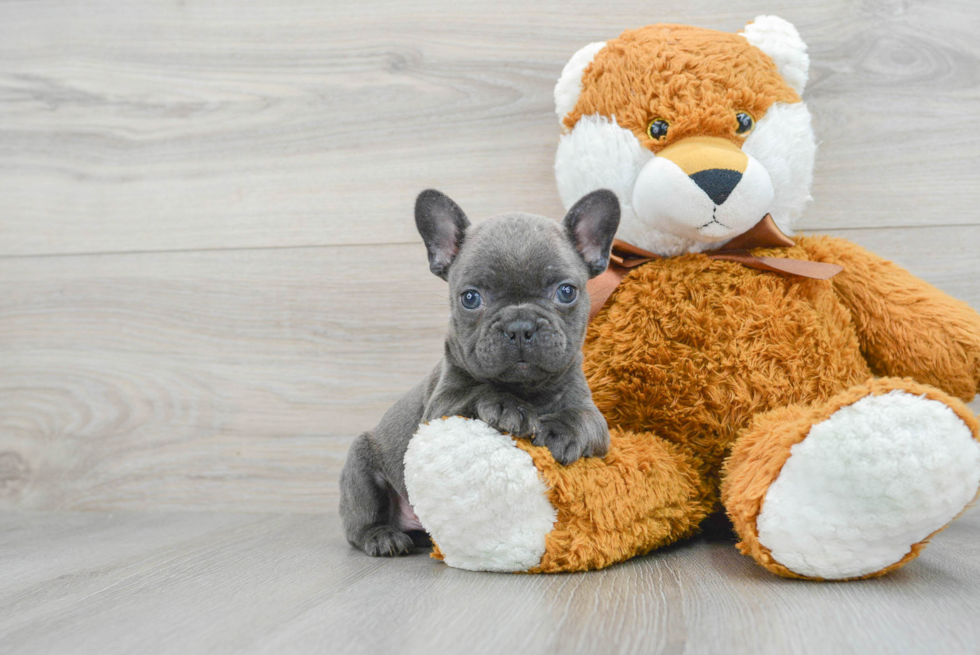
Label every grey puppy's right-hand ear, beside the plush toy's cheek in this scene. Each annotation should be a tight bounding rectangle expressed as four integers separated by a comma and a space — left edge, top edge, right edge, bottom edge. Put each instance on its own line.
562, 189, 619, 277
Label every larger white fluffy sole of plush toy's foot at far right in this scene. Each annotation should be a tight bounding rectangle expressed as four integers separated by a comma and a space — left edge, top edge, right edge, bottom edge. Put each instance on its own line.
756, 391, 980, 579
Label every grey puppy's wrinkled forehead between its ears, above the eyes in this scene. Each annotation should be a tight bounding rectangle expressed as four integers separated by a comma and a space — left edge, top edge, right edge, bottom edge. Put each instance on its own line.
449, 213, 588, 293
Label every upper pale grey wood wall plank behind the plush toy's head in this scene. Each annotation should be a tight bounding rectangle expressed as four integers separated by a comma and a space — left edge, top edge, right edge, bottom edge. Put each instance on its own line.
0, 0, 980, 255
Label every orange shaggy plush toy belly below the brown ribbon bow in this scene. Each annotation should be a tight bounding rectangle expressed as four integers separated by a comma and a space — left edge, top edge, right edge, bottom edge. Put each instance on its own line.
585, 248, 871, 472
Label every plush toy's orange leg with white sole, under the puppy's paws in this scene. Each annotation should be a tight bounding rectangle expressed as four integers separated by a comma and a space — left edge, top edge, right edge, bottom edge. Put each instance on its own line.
405, 417, 713, 573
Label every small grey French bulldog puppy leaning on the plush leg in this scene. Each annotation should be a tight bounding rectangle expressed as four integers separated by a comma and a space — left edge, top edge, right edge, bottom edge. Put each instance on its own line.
340, 189, 619, 556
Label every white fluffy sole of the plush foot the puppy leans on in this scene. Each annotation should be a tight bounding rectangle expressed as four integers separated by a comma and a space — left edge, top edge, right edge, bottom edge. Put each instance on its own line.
405, 416, 556, 571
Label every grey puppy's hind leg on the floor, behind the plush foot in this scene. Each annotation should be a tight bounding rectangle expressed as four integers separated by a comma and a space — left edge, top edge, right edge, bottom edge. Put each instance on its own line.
340, 432, 413, 557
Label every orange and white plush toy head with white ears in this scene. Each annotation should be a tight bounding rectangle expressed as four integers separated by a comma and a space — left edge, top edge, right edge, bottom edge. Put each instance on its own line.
555, 16, 816, 256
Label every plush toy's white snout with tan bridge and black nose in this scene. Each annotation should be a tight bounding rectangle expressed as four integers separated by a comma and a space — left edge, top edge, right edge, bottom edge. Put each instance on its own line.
633, 137, 773, 243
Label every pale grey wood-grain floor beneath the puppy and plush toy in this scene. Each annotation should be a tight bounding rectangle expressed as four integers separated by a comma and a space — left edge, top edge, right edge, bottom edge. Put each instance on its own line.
0, 509, 980, 655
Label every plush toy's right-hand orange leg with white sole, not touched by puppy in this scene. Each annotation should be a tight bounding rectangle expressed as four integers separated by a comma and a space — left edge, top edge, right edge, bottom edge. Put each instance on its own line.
722, 378, 980, 580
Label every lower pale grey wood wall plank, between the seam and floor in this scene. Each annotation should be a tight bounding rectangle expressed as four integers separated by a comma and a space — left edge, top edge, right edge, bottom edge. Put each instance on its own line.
0, 227, 980, 512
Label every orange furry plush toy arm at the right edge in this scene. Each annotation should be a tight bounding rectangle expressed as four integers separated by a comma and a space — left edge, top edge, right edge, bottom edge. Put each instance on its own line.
798, 237, 980, 402
